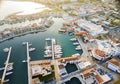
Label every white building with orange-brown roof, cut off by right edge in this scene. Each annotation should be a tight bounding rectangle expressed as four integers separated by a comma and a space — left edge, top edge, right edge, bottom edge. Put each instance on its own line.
107, 58, 120, 73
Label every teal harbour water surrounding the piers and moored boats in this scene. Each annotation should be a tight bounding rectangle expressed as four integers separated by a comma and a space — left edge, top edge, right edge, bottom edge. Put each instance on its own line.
0, 18, 82, 84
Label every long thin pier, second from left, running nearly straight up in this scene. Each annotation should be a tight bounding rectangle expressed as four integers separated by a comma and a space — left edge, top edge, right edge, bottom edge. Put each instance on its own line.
26, 42, 32, 84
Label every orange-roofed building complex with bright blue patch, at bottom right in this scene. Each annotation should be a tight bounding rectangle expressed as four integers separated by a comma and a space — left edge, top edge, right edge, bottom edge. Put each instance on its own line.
81, 68, 111, 84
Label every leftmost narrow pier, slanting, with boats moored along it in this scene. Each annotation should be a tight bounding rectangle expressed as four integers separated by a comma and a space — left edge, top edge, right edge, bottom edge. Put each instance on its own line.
1, 47, 12, 84
